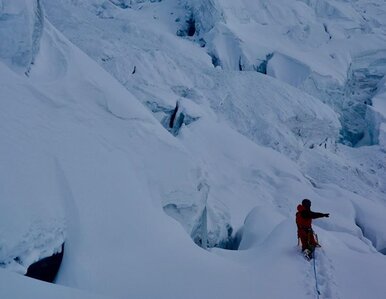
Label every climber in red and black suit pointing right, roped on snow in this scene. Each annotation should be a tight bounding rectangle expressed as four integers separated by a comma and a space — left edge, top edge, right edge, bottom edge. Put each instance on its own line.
296, 199, 330, 259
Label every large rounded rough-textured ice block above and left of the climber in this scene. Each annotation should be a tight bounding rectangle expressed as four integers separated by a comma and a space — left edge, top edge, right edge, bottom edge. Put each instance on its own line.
197, 71, 340, 159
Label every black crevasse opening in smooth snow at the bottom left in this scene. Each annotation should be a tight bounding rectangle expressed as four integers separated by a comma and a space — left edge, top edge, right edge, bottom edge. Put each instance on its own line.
25, 243, 64, 282
